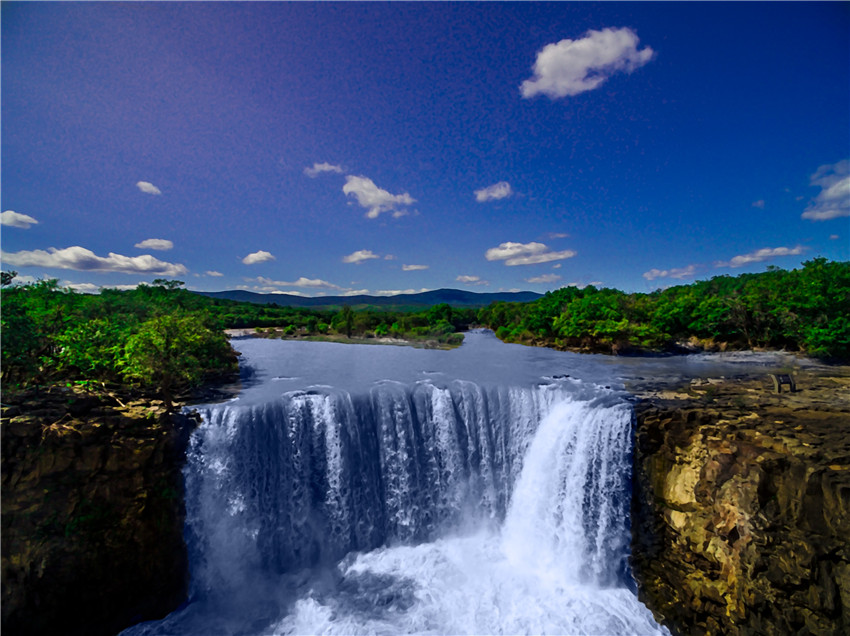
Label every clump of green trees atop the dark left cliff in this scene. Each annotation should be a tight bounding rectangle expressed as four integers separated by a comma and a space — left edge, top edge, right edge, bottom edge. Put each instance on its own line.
0, 280, 236, 407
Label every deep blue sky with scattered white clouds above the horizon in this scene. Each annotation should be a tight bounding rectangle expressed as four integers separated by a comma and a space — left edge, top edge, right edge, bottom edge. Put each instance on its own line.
0, 2, 850, 296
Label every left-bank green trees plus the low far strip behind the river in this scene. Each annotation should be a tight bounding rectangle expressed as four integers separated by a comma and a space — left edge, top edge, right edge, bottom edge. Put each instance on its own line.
0, 280, 475, 408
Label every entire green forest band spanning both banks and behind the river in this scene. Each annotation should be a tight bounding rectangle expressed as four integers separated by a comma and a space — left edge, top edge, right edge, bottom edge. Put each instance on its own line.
0, 258, 850, 405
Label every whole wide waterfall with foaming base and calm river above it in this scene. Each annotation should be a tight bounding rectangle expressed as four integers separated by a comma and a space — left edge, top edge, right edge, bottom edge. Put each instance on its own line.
124, 332, 796, 636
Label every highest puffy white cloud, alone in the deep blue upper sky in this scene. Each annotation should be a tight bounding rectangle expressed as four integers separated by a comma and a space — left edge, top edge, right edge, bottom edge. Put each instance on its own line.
520, 28, 655, 99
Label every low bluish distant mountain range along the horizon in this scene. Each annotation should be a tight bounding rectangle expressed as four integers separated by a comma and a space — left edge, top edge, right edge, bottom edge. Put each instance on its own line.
195, 289, 542, 307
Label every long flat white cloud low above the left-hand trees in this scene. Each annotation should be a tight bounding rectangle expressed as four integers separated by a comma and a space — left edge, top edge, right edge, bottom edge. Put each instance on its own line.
2, 245, 189, 276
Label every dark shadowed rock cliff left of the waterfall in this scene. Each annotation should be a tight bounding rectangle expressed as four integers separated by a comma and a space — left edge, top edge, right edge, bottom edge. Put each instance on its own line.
2, 390, 195, 636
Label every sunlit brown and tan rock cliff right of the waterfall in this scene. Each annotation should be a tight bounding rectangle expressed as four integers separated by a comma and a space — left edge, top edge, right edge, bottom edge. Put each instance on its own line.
632, 368, 850, 635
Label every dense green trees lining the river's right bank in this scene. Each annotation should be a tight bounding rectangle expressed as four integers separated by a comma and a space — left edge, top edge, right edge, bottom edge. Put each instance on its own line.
478, 258, 850, 360
